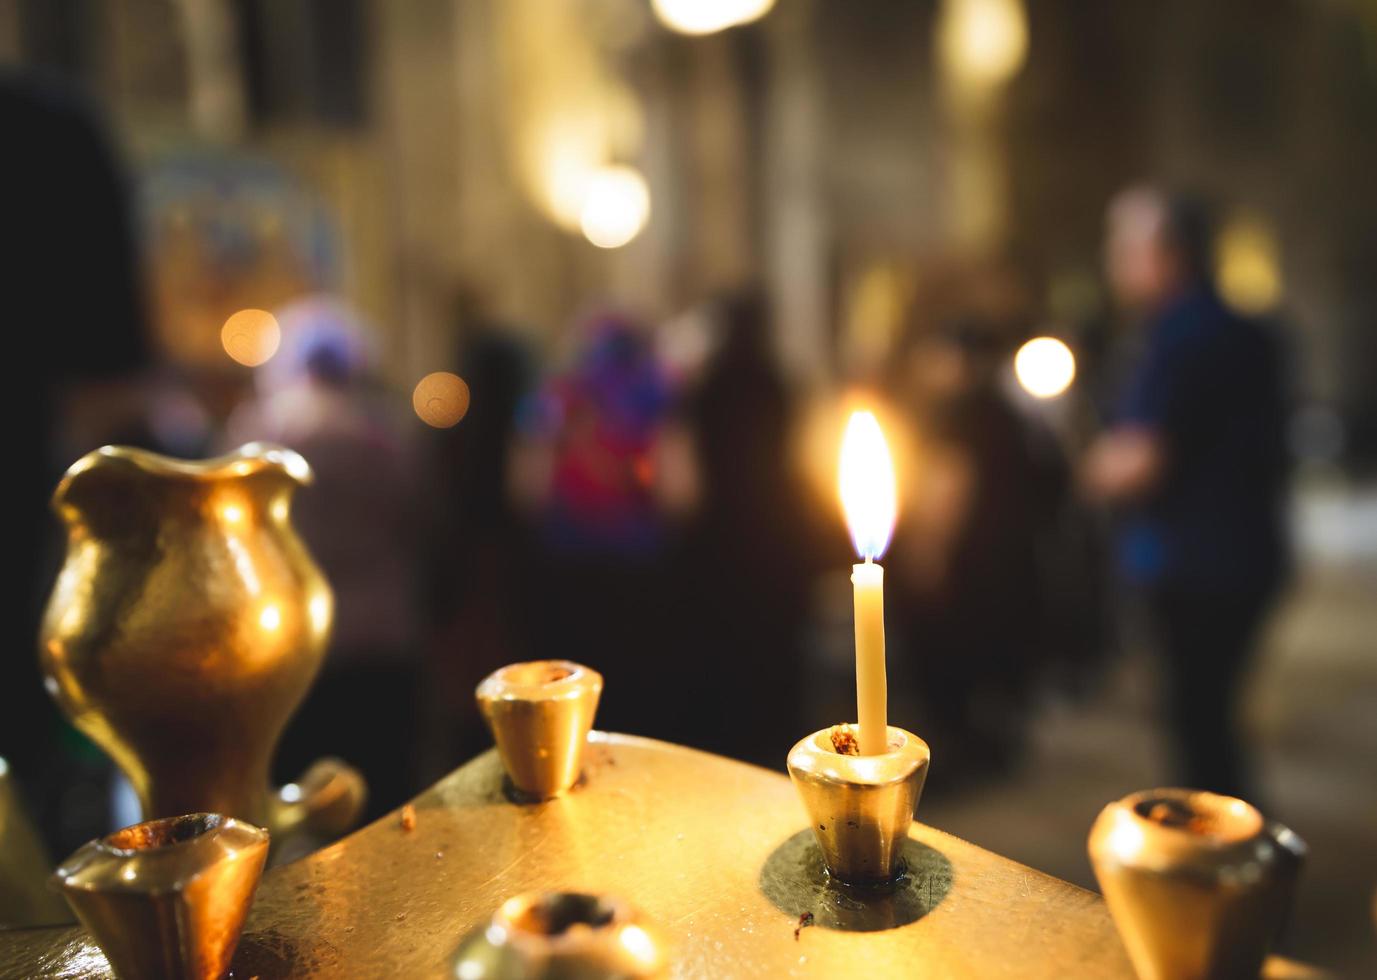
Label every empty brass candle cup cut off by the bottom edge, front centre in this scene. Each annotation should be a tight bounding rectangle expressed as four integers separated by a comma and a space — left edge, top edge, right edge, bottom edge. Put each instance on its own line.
453, 892, 669, 980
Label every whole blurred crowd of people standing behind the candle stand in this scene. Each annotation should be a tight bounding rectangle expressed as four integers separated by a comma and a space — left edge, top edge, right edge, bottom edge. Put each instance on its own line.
8, 68, 1286, 849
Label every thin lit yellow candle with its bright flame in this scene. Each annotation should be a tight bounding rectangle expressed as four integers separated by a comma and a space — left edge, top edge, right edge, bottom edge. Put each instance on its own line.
840, 412, 896, 756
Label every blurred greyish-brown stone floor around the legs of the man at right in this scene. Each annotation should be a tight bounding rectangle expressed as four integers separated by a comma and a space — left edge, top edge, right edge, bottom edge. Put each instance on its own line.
918, 486, 1377, 977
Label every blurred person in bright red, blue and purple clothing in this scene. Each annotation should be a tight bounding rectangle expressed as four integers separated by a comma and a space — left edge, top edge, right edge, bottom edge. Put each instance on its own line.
512, 315, 679, 735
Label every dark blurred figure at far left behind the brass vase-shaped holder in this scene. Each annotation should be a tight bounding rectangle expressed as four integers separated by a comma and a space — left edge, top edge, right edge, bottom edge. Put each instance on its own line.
0, 70, 154, 855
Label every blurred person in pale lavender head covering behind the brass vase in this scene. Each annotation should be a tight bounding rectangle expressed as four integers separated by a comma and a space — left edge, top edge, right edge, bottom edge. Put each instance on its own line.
226, 297, 425, 819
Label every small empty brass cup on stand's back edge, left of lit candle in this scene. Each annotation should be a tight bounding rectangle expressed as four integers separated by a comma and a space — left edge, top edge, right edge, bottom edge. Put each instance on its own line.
475, 661, 602, 800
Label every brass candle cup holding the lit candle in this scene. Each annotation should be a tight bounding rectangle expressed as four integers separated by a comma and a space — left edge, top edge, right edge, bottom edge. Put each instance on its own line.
789, 725, 931, 885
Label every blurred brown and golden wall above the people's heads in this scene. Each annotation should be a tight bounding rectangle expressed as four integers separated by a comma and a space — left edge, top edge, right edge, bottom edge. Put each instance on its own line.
8, 0, 1377, 457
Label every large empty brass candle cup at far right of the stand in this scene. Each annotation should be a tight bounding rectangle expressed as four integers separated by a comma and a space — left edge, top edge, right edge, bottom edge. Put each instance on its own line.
1089, 789, 1305, 980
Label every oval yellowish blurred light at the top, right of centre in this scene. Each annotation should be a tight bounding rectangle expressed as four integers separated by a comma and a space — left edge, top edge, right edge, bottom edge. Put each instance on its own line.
938, 0, 1029, 87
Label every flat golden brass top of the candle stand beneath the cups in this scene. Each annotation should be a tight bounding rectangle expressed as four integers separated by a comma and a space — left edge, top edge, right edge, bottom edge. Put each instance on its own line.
0, 732, 1327, 980
